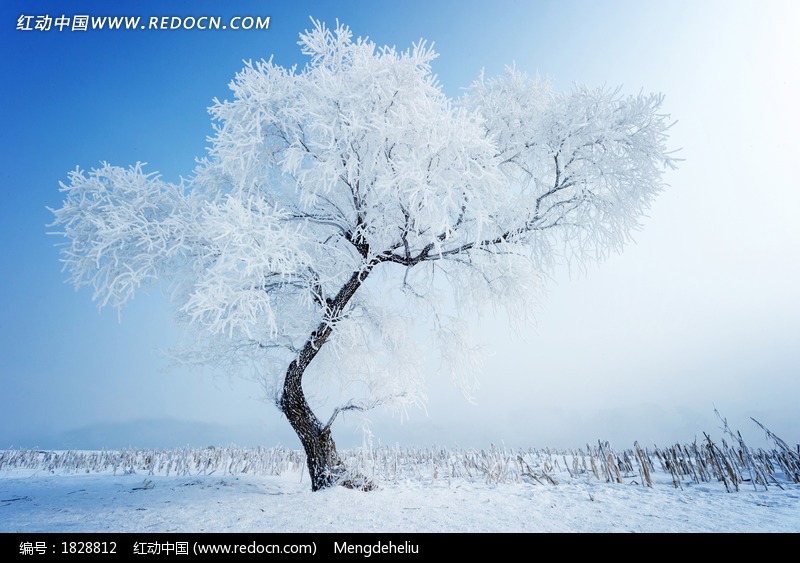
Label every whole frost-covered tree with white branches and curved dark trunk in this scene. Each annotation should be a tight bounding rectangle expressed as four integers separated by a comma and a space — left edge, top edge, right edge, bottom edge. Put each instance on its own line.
48, 22, 673, 490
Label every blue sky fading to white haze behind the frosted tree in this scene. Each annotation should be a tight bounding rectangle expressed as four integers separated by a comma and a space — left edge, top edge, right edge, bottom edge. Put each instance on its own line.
0, 0, 800, 447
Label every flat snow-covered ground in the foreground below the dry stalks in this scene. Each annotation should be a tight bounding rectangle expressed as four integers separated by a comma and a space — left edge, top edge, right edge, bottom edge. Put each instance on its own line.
0, 450, 800, 533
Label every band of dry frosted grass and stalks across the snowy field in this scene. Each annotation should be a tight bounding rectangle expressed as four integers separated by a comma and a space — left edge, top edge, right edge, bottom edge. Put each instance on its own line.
0, 417, 800, 492
